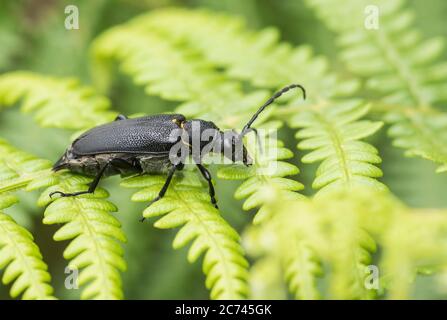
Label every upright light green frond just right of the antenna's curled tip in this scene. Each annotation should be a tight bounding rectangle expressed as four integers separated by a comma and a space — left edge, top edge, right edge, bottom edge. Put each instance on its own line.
290, 101, 385, 191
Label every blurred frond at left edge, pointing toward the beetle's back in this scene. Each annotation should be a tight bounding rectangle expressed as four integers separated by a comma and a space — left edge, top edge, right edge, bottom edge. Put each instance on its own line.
0, 71, 116, 129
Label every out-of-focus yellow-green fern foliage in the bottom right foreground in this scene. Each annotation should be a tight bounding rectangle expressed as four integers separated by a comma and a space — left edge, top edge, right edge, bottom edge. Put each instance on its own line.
245, 188, 447, 299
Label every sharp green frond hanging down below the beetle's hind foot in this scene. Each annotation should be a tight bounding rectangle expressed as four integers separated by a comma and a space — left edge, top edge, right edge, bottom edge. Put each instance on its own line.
38, 173, 126, 299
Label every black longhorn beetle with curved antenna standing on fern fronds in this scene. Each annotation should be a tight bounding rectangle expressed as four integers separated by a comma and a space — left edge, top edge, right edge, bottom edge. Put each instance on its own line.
50, 84, 306, 212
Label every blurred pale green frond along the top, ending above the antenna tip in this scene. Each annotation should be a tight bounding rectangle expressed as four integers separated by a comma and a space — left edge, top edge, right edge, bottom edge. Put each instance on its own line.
135, 9, 346, 96
